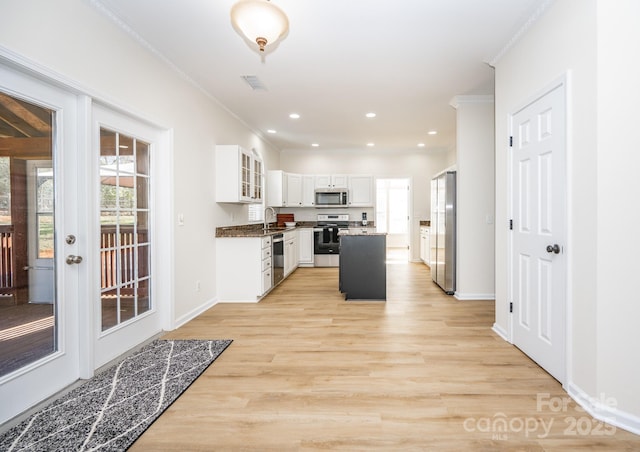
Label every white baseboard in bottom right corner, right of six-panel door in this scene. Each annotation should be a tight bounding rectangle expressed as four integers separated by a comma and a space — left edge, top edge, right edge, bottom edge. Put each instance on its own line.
565, 383, 640, 435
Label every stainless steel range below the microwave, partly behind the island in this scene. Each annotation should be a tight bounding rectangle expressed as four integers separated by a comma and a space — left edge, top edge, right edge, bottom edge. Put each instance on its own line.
313, 214, 349, 267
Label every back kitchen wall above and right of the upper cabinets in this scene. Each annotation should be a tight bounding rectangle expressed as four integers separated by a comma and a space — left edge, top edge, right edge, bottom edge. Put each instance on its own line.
280, 149, 451, 260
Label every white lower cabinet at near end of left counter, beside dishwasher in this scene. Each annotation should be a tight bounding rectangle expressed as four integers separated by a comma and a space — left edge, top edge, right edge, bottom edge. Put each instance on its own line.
216, 236, 272, 302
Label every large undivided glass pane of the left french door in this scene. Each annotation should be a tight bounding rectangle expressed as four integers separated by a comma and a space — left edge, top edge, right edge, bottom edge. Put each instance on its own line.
0, 92, 58, 377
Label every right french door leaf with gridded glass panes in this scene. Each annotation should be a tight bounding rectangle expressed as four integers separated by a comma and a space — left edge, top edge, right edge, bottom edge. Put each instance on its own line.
92, 105, 163, 368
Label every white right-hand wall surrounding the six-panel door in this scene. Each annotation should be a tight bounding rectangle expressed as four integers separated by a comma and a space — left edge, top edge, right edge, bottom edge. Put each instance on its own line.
496, 0, 640, 432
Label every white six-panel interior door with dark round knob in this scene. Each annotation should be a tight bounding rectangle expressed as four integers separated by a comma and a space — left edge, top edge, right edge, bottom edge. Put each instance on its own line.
511, 84, 567, 382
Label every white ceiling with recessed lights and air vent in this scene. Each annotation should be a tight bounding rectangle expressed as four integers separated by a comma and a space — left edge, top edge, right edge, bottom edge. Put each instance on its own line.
94, 0, 546, 152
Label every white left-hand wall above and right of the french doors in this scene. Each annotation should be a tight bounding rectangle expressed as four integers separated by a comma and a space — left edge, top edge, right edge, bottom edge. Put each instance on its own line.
0, 0, 279, 320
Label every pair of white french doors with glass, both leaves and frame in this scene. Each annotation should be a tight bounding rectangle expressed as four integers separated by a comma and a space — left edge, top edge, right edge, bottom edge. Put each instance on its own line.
0, 61, 172, 424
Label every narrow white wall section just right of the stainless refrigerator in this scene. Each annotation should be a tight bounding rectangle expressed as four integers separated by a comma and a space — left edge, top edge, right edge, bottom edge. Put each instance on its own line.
452, 95, 495, 300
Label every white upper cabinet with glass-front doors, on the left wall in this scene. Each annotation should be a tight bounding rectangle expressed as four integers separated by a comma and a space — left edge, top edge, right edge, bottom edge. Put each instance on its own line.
216, 144, 264, 203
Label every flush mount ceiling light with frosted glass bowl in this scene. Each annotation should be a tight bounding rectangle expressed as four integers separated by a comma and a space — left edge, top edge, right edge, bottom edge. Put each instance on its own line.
231, 0, 289, 52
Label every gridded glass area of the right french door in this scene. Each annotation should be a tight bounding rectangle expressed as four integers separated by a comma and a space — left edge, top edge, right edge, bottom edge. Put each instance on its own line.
100, 128, 151, 331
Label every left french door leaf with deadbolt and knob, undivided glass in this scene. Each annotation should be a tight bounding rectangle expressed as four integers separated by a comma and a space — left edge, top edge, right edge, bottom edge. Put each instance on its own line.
0, 62, 84, 424
